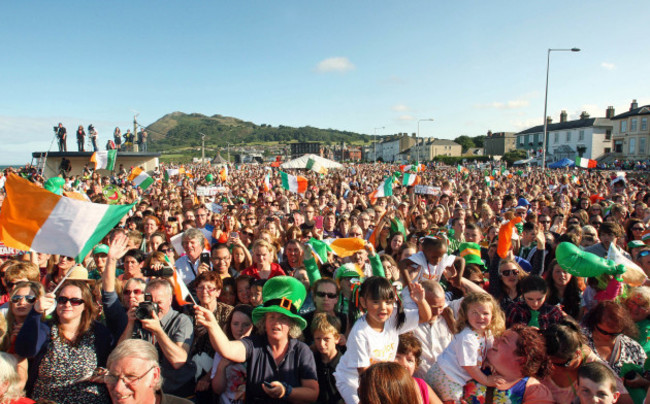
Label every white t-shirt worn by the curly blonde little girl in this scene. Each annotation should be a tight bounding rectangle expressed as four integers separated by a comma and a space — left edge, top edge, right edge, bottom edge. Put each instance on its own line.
438, 327, 494, 386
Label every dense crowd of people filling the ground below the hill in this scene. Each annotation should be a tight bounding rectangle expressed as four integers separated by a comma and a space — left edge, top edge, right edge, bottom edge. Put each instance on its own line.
0, 159, 650, 404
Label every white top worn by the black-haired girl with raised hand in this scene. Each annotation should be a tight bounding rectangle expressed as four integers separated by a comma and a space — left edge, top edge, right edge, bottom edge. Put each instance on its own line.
334, 289, 419, 386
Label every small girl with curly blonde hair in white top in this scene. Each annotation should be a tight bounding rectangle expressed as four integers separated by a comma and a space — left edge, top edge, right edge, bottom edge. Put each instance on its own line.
425, 293, 505, 402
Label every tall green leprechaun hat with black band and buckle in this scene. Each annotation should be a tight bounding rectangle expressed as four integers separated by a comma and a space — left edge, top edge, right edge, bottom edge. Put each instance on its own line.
253, 276, 307, 330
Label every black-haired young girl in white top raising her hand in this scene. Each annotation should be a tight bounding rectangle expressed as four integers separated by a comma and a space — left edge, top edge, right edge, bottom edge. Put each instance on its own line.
334, 276, 431, 404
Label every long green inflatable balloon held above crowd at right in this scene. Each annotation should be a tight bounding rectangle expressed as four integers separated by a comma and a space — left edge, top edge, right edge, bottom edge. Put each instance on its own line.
555, 241, 625, 277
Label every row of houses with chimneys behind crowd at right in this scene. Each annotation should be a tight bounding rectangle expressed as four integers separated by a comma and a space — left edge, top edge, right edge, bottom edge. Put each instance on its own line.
485, 100, 650, 162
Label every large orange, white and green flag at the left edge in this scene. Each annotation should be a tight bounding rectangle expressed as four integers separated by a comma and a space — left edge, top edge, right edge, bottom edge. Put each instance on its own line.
0, 174, 135, 262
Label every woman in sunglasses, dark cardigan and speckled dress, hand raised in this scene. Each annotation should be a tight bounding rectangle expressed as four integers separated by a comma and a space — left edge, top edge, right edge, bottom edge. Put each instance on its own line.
15, 280, 117, 404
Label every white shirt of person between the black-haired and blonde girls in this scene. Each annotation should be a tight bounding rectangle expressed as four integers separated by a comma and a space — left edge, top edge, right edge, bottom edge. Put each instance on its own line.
413, 298, 463, 379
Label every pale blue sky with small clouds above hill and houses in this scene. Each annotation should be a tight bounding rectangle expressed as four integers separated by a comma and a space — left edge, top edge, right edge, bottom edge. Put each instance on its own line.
0, 0, 650, 164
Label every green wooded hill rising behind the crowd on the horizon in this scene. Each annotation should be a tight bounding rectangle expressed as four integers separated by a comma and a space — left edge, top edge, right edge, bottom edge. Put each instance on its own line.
147, 112, 372, 151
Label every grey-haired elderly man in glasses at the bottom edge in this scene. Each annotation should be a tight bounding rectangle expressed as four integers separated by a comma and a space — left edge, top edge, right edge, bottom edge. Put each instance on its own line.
104, 339, 191, 404
